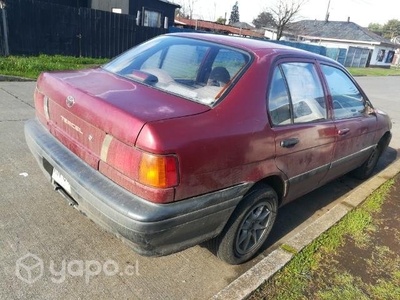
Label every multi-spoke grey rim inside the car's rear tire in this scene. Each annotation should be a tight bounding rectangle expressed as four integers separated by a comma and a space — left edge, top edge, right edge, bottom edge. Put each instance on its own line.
235, 203, 271, 255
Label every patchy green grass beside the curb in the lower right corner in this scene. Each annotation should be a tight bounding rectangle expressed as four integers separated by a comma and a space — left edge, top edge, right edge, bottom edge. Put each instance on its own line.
249, 179, 394, 300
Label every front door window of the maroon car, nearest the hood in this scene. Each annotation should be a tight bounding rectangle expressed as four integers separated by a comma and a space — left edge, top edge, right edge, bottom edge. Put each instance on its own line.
321, 65, 365, 120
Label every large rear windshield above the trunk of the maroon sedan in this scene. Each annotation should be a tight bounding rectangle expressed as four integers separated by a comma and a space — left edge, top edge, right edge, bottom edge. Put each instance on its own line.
103, 36, 250, 105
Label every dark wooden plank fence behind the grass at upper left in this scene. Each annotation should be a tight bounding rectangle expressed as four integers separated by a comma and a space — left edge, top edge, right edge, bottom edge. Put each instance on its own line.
0, 0, 166, 58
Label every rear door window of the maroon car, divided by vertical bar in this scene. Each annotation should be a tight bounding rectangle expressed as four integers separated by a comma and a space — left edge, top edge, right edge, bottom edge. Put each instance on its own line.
268, 62, 327, 125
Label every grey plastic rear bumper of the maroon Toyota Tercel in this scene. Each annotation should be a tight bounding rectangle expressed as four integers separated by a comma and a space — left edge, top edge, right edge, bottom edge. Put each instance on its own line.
25, 119, 251, 256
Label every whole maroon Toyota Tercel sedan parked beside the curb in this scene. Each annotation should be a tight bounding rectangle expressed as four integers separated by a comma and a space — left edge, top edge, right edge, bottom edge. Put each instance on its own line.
25, 33, 391, 264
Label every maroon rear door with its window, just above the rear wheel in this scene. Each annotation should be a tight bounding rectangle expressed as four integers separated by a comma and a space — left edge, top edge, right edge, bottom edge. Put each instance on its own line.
268, 60, 336, 202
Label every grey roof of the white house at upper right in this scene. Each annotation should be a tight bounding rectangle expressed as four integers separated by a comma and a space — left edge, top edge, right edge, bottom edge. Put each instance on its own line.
290, 20, 394, 45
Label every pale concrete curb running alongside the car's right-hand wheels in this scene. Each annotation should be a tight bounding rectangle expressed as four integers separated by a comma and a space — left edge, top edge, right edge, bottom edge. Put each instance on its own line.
211, 159, 400, 300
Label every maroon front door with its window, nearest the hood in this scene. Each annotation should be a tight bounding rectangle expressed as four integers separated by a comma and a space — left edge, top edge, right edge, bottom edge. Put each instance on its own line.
321, 64, 377, 182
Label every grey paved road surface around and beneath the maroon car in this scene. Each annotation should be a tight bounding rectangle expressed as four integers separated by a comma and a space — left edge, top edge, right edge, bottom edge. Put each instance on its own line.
0, 77, 400, 299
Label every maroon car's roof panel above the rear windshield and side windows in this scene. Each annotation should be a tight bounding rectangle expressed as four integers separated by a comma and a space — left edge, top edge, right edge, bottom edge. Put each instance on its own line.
167, 32, 337, 64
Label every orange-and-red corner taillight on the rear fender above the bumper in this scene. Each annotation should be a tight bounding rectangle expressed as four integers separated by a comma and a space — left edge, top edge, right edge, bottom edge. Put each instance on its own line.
138, 152, 178, 188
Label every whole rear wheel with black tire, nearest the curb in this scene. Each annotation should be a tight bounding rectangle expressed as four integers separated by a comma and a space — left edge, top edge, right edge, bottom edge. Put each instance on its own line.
214, 185, 278, 265
